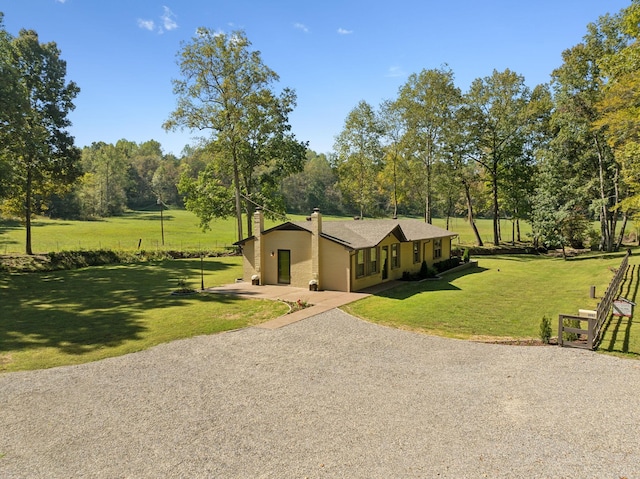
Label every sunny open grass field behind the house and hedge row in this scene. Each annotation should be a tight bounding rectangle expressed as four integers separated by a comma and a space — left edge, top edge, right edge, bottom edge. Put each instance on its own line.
0, 209, 544, 254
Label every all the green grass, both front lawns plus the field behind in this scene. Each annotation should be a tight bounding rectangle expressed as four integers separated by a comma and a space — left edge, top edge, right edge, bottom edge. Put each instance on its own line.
0, 210, 640, 372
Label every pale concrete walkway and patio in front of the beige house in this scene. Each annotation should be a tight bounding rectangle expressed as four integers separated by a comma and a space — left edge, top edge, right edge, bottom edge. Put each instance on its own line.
207, 281, 399, 329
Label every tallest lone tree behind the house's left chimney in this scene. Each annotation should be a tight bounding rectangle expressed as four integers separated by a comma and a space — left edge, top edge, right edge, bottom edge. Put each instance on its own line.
164, 28, 304, 239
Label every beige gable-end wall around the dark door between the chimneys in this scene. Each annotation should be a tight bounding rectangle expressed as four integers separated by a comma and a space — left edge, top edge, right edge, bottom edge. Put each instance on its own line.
262, 231, 311, 288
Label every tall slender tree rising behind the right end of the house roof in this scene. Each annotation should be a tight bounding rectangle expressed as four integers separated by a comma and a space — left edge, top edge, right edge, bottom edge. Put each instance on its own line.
396, 67, 461, 223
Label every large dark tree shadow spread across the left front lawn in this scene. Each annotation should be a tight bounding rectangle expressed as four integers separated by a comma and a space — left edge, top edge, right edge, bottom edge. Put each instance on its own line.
0, 259, 242, 355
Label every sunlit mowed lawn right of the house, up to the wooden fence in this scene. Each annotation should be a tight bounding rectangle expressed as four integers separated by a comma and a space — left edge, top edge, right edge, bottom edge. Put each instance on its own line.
345, 251, 640, 353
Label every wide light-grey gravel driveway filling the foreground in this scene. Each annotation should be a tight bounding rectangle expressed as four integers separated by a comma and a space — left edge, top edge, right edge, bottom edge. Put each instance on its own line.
0, 310, 640, 479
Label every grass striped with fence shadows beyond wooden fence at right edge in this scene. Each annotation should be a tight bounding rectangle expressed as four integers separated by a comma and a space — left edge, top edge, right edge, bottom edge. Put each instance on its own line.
599, 265, 640, 356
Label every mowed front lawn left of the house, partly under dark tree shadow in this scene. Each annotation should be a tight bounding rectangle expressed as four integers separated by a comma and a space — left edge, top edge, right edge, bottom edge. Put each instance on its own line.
0, 257, 288, 372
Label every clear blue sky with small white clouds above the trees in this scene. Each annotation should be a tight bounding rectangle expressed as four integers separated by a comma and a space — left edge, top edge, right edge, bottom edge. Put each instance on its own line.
0, 0, 631, 155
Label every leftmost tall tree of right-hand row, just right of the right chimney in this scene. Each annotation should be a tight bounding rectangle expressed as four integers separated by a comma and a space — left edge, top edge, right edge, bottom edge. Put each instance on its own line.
334, 100, 383, 218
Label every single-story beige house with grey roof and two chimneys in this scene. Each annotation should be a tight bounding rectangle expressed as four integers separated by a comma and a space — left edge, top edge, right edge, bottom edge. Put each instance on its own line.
237, 208, 457, 291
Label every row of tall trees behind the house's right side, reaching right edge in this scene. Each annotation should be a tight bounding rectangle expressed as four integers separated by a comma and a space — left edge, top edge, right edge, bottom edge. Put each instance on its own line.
333, 1, 640, 255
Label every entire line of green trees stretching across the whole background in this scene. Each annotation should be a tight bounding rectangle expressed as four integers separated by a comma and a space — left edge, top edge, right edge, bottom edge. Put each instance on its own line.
0, 0, 640, 253
